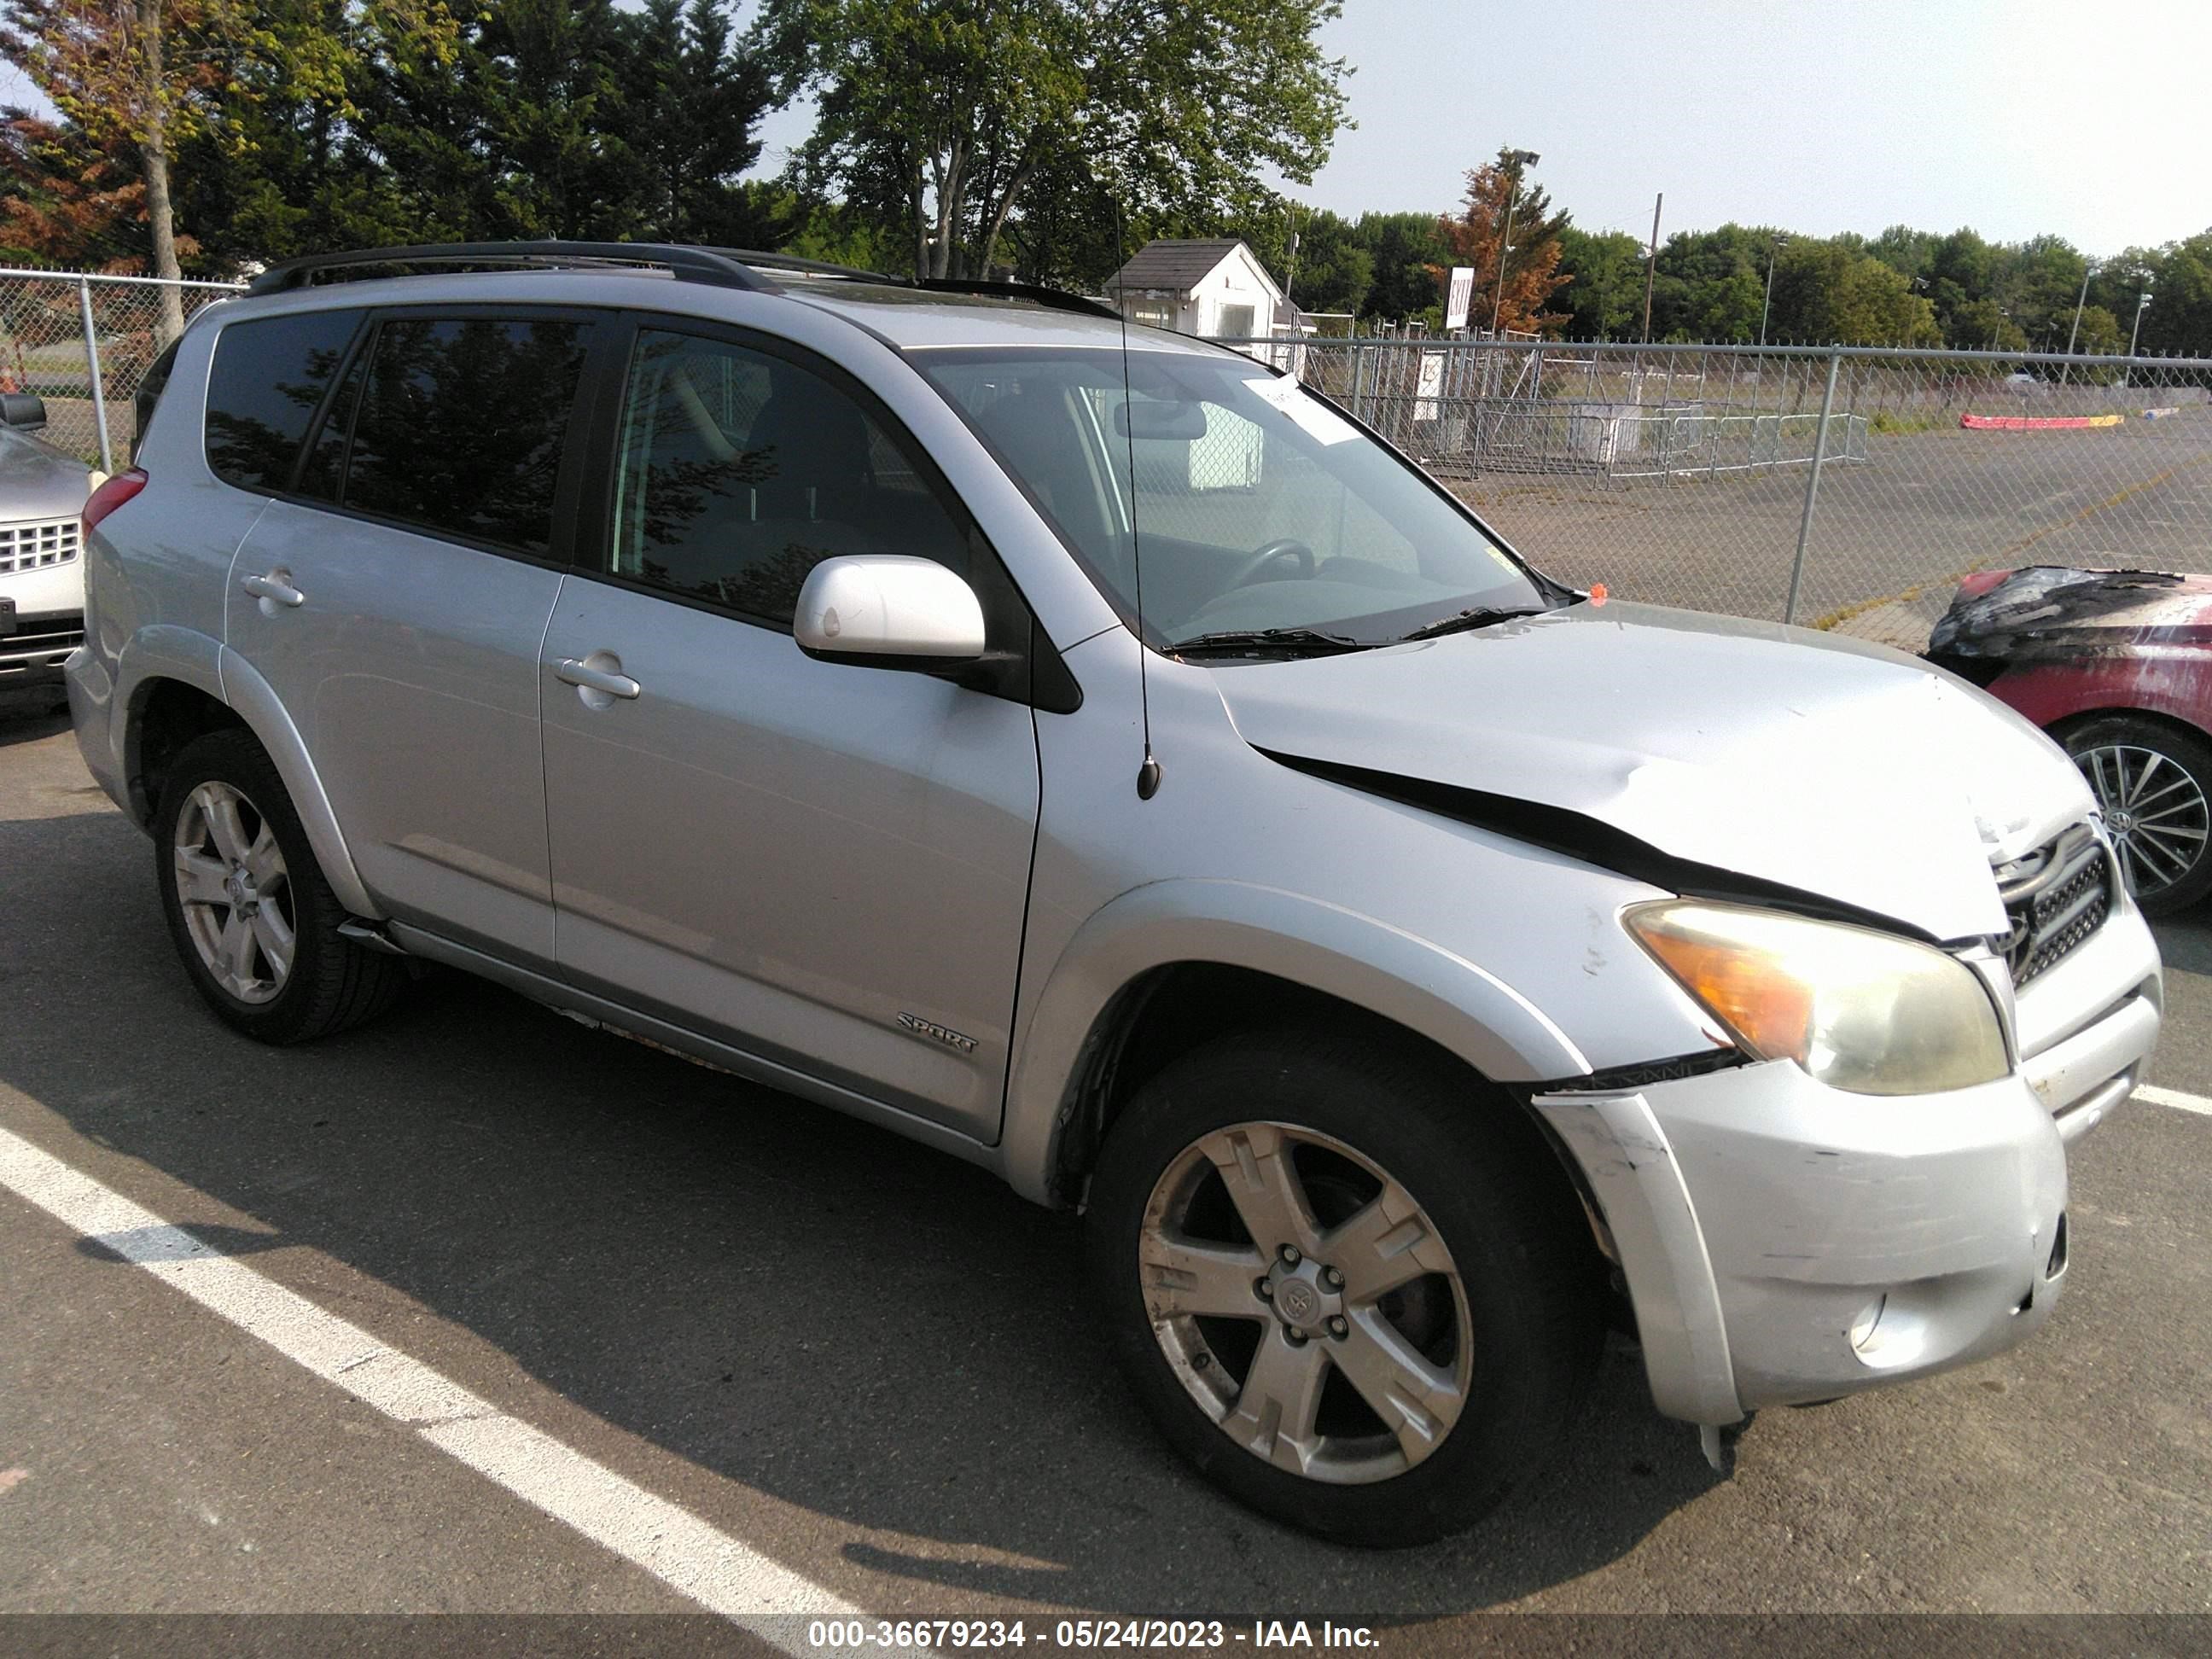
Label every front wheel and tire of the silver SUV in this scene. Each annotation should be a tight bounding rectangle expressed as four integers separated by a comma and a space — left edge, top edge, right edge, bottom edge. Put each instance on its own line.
1088, 1033, 1602, 1546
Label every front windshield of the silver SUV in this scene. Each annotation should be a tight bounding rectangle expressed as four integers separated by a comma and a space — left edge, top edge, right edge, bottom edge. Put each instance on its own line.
911, 347, 1548, 650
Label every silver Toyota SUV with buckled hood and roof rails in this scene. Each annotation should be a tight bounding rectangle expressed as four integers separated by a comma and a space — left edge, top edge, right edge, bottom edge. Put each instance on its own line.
68, 243, 2161, 1544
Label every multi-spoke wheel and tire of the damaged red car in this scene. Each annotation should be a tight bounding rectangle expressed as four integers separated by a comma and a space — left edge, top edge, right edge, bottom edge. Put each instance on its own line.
2066, 714, 2212, 916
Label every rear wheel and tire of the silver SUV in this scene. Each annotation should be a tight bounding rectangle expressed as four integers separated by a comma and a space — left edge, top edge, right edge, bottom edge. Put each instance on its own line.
153, 730, 407, 1044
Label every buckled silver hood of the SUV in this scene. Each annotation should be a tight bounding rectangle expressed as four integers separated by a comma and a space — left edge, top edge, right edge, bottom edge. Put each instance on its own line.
1214, 602, 2093, 940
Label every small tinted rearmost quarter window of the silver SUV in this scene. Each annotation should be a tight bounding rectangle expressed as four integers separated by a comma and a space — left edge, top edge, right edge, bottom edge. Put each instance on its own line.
208, 311, 360, 491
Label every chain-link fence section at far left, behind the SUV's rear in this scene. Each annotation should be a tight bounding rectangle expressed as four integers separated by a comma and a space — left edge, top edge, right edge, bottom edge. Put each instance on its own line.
0, 270, 239, 471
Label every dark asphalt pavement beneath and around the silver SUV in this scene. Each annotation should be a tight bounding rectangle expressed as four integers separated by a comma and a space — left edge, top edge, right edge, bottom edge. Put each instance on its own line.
0, 690, 2212, 1652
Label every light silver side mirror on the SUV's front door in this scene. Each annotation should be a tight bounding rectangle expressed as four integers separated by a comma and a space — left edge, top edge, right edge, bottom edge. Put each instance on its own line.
792, 553, 989, 670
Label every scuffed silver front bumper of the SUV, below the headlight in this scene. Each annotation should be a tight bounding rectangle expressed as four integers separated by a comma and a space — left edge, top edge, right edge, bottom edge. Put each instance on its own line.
1533, 907, 2159, 1424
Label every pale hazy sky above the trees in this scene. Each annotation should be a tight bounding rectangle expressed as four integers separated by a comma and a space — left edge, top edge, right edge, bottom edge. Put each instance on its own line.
738, 0, 2212, 257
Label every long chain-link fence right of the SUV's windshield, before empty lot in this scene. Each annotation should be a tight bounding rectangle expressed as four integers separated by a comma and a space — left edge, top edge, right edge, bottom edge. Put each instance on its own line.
1243, 339, 2212, 650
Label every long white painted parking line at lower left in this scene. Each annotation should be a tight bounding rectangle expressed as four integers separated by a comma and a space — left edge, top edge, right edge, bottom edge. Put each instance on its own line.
0, 1128, 859, 1652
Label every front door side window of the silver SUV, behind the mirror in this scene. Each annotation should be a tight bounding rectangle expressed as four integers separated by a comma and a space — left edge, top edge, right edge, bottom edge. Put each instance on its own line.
613, 329, 971, 624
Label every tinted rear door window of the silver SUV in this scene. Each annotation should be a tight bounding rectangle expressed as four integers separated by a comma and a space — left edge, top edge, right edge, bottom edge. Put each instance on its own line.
345, 317, 586, 553
